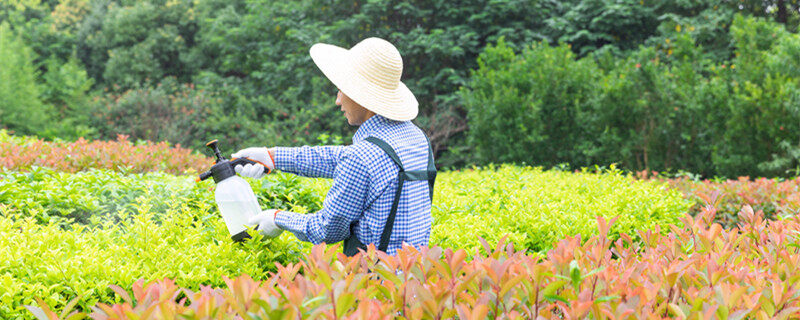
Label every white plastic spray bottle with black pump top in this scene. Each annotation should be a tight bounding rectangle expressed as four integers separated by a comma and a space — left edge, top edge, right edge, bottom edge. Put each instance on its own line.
197, 140, 261, 242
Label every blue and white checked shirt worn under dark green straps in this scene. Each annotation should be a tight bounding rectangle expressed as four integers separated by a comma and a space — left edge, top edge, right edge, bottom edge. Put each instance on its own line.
275, 115, 431, 255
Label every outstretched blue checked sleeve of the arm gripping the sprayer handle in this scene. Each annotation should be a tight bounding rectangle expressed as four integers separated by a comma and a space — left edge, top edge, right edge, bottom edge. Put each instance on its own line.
275, 146, 347, 178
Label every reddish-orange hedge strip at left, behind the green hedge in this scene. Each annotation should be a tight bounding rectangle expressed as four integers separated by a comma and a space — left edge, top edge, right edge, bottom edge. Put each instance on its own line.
0, 130, 214, 174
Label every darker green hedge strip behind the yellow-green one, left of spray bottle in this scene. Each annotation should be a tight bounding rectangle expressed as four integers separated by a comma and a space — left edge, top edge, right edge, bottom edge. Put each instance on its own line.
0, 167, 208, 227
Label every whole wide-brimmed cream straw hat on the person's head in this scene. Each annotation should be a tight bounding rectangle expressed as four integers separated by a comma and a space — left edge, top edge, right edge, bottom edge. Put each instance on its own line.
310, 38, 419, 121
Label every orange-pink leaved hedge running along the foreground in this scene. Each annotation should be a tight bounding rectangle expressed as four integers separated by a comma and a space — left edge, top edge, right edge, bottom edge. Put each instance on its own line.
30, 206, 800, 320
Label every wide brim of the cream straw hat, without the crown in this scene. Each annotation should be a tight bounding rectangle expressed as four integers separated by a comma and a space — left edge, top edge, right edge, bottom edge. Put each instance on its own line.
309, 43, 419, 121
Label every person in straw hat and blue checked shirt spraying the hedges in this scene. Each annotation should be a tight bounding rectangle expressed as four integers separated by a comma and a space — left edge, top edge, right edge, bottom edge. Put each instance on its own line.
231, 38, 436, 256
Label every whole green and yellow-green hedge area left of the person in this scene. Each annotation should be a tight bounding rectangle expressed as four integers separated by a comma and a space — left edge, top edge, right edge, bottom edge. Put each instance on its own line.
0, 168, 322, 319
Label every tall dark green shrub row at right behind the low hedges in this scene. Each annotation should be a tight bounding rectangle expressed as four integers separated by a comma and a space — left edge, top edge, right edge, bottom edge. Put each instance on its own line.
462, 16, 800, 177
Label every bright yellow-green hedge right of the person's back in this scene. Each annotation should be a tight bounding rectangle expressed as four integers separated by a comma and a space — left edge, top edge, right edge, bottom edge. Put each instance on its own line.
430, 165, 692, 252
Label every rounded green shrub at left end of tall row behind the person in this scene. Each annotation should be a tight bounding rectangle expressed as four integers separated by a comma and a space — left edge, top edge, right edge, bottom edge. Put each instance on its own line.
462, 39, 598, 166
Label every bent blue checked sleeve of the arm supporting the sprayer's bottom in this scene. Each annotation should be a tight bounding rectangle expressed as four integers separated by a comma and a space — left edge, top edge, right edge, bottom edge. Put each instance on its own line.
275, 154, 370, 244
